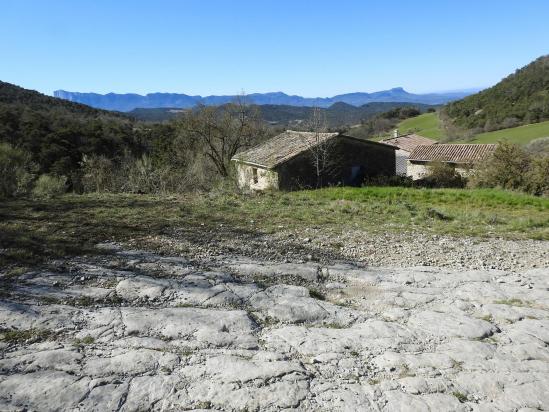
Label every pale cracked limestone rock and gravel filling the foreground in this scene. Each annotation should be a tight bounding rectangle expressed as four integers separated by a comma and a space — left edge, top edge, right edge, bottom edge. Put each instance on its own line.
0, 238, 549, 411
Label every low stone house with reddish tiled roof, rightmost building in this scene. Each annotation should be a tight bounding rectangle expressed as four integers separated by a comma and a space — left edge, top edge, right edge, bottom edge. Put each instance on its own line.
407, 144, 497, 180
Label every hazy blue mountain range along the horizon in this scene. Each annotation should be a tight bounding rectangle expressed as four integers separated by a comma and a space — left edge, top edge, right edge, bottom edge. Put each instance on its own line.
53, 87, 474, 112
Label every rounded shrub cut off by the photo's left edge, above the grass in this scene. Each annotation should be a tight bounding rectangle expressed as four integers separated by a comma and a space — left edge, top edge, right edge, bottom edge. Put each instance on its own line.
0, 143, 36, 197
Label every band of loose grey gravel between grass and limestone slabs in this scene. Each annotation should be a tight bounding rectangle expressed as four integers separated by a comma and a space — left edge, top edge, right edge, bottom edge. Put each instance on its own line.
134, 228, 549, 270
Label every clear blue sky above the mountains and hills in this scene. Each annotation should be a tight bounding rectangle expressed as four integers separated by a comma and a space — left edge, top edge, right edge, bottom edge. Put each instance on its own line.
0, 0, 549, 97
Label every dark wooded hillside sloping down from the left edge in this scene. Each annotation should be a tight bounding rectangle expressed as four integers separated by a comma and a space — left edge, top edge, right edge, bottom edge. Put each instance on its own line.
0, 82, 156, 177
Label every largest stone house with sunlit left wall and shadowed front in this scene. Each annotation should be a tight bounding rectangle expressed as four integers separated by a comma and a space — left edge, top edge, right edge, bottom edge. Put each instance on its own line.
232, 130, 396, 191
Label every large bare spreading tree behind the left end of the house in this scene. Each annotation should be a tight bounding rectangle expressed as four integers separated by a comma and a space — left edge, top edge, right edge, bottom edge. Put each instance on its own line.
179, 96, 266, 177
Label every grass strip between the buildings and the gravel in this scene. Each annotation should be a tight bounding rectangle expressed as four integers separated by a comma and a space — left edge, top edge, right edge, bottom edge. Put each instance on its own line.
0, 187, 549, 266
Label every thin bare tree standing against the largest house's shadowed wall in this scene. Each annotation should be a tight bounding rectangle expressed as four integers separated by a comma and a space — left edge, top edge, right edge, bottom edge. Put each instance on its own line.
304, 107, 337, 188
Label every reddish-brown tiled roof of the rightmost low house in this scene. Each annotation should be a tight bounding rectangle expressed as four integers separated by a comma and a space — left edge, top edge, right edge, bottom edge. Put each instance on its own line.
408, 144, 497, 163
